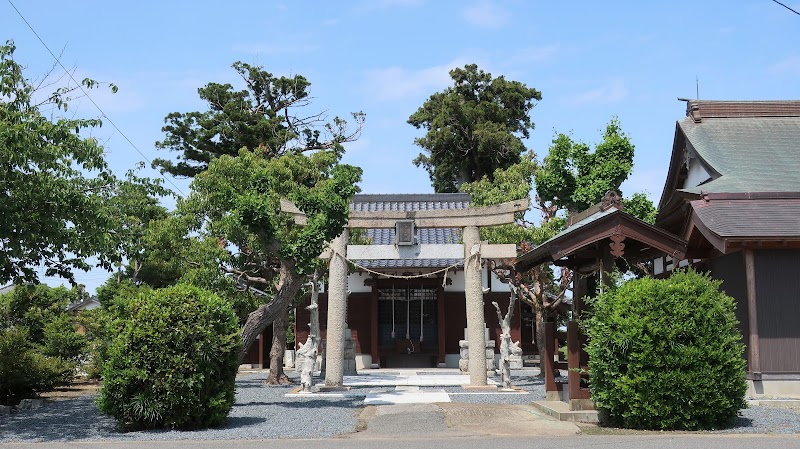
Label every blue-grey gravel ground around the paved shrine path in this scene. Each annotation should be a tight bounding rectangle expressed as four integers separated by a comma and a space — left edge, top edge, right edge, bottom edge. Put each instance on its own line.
0, 373, 800, 444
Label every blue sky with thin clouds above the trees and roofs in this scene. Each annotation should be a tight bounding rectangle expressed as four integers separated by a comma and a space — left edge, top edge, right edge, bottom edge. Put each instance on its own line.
0, 0, 800, 291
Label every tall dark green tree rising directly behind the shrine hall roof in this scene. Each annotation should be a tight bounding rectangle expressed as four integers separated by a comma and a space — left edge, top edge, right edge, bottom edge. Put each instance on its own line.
408, 64, 542, 192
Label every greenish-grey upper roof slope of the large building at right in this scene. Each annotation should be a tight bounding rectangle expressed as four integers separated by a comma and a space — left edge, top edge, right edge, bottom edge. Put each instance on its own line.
679, 114, 800, 194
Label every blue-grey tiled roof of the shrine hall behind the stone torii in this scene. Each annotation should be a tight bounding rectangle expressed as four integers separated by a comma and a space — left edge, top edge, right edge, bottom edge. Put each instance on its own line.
350, 193, 471, 269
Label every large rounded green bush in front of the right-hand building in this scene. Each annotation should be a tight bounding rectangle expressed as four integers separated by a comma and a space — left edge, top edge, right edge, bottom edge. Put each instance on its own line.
584, 270, 747, 430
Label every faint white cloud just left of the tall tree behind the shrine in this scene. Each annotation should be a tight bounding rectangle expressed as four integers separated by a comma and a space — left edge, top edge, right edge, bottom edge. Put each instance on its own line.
367, 59, 476, 101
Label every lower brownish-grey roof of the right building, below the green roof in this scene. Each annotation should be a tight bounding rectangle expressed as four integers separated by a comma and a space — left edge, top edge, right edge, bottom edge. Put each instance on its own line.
691, 198, 800, 239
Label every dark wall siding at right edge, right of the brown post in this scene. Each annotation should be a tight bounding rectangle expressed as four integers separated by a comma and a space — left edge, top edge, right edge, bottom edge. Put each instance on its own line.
754, 250, 800, 373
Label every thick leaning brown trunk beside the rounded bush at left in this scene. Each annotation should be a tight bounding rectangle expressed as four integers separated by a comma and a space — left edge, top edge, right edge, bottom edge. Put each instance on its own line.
239, 261, 303, 363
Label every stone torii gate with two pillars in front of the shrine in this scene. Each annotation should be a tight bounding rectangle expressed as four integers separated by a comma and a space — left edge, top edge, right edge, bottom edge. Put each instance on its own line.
281, 198, 530, 388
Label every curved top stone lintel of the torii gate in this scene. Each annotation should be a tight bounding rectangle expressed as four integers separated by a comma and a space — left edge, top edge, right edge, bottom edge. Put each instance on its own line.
281, 198, 530, 229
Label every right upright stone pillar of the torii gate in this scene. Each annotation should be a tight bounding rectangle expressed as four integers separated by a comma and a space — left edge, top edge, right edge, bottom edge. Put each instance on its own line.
463, 226, 488, 387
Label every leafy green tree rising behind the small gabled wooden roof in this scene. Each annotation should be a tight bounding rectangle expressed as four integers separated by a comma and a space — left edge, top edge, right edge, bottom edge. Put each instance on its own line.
462, 118, 655, 370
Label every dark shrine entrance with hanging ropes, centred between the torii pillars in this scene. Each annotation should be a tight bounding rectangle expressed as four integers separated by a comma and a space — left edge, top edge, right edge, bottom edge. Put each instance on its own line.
378, 284, 439, 368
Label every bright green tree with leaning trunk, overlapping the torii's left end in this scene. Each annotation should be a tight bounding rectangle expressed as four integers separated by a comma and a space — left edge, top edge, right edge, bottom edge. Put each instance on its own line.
180, 147, 361, 383
